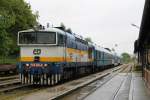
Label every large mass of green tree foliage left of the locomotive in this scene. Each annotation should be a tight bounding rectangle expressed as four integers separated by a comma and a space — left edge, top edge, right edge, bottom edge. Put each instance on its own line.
0, 0, 38, 56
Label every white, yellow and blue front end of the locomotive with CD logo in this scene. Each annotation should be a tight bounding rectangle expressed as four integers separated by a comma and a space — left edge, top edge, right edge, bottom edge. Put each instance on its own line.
18, 30, 64, 85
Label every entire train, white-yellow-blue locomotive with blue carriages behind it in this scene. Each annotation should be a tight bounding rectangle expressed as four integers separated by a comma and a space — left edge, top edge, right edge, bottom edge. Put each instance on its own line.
17, 27, 121, 85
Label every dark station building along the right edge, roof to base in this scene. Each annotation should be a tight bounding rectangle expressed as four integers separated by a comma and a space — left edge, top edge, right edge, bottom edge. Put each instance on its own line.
134, 0, 150, 89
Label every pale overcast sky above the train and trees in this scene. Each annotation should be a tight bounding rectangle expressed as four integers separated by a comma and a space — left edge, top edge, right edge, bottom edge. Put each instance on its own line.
25, 0, 145, 54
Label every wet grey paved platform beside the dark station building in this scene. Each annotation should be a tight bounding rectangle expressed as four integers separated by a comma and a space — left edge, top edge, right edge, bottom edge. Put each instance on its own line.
84, 72, 150, 100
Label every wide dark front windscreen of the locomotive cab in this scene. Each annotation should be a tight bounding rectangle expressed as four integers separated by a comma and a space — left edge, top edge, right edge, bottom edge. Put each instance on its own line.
19, 32, 56, 44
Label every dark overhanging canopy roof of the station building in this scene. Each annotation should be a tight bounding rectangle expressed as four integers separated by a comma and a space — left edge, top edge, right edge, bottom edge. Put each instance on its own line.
134, 0, 150, 53
